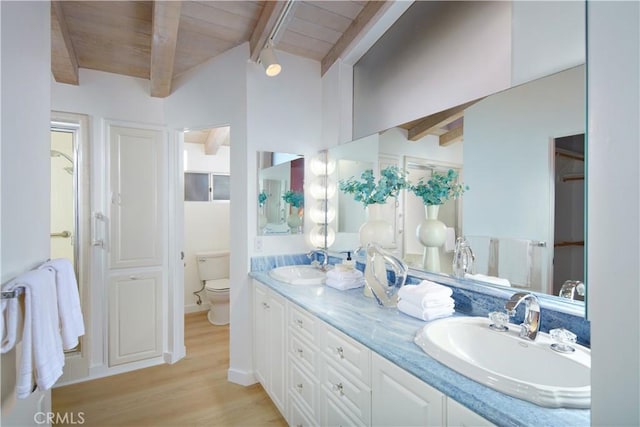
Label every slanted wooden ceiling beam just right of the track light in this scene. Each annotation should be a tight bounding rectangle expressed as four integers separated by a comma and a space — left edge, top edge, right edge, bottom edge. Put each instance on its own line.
320, 1, 393, 76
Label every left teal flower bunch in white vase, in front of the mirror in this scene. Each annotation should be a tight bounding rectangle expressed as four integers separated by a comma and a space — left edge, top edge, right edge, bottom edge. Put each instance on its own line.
338, 166, 409, 207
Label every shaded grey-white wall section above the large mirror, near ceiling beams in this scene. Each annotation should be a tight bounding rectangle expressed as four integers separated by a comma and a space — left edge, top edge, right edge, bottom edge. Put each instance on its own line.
353, 1, 511, 138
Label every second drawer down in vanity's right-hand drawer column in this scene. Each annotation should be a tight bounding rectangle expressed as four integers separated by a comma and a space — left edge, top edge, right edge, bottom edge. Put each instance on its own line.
322, 363, 371, 425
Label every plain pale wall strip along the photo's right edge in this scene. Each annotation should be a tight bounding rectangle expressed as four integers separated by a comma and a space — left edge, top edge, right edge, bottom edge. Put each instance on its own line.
587, 1, 640, 426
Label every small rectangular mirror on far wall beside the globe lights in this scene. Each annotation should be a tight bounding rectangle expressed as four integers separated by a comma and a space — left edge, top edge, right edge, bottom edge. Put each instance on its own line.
256, 151, 304, 235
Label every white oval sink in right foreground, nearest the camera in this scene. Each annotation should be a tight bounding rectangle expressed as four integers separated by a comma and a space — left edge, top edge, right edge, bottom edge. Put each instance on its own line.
414, 317, 591, 408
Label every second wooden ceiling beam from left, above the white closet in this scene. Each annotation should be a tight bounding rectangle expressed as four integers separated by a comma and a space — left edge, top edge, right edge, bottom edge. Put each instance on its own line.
149, 1, 182, 98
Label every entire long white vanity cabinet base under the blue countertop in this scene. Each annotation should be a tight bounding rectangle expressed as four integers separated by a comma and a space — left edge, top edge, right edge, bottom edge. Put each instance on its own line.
254, 281, 492, 427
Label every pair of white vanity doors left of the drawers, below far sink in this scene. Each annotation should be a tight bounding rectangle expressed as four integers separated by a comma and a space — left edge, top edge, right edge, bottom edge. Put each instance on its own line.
253, 281, 287, 414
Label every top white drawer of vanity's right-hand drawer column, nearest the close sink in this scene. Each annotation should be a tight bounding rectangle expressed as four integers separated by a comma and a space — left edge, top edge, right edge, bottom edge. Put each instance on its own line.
322, 326, 371, 386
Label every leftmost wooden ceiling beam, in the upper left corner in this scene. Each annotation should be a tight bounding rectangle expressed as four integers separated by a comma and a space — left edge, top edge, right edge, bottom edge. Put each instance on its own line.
51, 0, 80, 86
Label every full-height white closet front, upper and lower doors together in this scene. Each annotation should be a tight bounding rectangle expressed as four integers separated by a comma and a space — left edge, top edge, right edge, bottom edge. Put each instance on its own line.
108, 125, 168, 366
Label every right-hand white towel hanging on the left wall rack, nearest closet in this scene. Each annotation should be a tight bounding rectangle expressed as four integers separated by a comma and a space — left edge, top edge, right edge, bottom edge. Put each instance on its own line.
40, 258, 84, 350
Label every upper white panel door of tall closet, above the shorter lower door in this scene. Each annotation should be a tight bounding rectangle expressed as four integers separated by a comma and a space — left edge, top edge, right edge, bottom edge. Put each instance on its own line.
109, 126, 164, 268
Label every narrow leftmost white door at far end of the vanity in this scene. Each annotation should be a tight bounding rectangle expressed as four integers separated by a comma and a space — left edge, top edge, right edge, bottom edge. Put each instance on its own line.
253, 281, 269, 390
